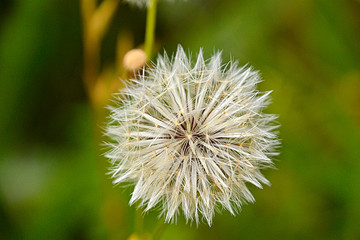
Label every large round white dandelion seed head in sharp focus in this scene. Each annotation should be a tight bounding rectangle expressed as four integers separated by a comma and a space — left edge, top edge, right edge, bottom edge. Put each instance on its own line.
106, 46, 278, 225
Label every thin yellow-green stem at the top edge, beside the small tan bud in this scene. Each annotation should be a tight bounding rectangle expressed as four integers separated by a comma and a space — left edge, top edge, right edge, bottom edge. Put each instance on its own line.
145, 0, 157, 60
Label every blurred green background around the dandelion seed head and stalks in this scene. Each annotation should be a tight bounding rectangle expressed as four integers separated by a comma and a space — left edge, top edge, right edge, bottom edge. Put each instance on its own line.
0, 0, 360, 240
